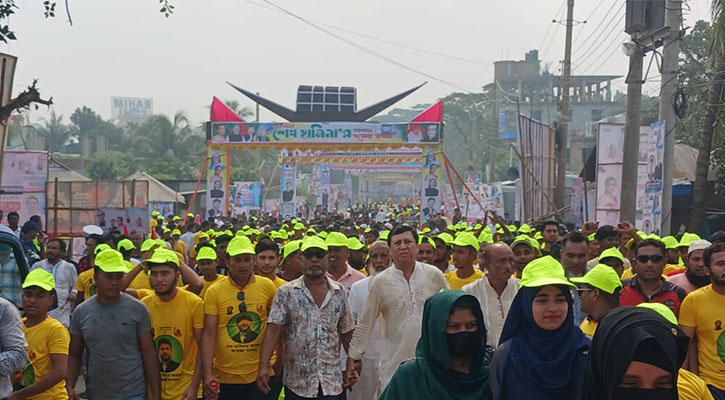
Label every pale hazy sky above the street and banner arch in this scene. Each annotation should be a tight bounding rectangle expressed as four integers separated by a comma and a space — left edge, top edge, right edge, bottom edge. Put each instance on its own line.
0, 0, 710, 126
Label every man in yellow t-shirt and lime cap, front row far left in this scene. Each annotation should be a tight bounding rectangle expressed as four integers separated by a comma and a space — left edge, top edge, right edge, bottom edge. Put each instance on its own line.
10, 268, 70, 400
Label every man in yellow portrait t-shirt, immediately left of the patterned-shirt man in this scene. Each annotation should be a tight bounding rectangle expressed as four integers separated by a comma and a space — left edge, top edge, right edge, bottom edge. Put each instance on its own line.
202, 236, 277, 400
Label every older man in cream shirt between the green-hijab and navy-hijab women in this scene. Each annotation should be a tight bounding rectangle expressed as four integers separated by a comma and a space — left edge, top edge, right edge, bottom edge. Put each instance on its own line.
463, 243, 519, 349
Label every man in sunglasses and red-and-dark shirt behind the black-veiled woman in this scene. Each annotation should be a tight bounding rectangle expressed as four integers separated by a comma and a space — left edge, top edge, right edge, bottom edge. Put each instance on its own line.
620, 239, 685, 317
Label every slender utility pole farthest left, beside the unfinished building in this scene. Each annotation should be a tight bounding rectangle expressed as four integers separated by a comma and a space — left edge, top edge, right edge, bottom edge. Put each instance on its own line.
554, 0, 574, 209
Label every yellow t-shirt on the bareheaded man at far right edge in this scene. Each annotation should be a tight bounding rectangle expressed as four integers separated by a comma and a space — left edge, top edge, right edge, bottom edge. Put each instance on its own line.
680, 284, 725, 390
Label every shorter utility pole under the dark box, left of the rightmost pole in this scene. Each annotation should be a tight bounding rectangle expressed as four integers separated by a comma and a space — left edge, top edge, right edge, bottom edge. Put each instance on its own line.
619, 45, 644, 223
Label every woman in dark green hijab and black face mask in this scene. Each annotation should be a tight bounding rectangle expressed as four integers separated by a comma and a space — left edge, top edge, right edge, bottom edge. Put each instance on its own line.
380, 290, 493, 400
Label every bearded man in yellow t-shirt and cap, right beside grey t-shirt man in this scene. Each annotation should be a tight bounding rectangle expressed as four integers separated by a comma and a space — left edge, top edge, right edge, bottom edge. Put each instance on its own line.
141, 249, 204, 400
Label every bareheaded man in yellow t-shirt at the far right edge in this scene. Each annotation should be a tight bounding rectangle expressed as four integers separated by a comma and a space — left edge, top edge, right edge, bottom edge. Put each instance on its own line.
680, 243, 725, 399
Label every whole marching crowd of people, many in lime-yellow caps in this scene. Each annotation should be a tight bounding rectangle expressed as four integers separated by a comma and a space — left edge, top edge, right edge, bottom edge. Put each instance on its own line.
0, 210, 725, 400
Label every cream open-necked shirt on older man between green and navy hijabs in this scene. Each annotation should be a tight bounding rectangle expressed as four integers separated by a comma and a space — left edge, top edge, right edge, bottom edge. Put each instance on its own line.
463, 276, 520, 349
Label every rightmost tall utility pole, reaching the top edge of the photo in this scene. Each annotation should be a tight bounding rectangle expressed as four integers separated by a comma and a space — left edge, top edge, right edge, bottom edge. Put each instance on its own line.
659, 0, 682, 236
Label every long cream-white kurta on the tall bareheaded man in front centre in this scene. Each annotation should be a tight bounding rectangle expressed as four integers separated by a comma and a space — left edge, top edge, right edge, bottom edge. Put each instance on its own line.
349, 261, 449, 393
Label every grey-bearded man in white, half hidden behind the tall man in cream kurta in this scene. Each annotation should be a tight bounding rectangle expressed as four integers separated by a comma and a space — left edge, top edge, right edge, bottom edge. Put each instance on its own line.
347, 240, 390, 400
